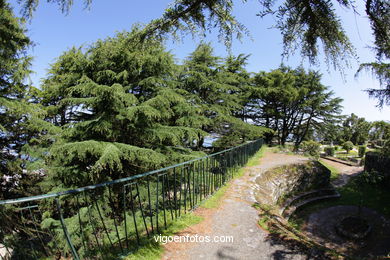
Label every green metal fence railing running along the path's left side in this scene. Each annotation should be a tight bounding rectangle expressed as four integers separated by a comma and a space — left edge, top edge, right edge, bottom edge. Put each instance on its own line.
0, 140, 263, 259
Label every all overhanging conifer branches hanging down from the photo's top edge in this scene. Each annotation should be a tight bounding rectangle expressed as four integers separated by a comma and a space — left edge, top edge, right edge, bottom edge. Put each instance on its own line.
14, 0, 390, 106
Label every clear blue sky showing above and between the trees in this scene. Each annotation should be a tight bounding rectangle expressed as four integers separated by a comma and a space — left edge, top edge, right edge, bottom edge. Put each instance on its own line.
10, 0, 390, 121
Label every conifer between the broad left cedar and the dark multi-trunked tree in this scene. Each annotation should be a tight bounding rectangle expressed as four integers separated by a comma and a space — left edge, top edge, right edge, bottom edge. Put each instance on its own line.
179, 43, 266, 148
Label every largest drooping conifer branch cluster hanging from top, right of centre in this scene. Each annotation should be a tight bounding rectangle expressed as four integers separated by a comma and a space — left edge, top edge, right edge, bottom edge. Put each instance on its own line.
260, 0, 355, 69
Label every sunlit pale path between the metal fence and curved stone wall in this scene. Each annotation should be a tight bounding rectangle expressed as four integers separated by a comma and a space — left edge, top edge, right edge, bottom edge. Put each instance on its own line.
163, 151, 307, 260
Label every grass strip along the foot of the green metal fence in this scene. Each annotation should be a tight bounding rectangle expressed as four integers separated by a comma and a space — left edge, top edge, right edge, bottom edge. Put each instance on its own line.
123, 146, 267, 260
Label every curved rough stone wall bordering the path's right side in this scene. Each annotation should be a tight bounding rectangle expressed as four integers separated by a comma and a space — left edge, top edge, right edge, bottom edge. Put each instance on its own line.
255, 160, 330, 206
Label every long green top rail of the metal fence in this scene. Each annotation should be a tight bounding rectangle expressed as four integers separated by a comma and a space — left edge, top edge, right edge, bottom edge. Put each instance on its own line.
0, 139, 260, 205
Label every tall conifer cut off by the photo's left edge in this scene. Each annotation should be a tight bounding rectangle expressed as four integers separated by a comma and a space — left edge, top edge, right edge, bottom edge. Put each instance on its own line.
0, 0, 56, 255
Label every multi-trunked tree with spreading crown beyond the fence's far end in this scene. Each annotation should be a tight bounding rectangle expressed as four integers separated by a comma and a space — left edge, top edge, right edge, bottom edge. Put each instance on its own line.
247, 67, 342, 148
